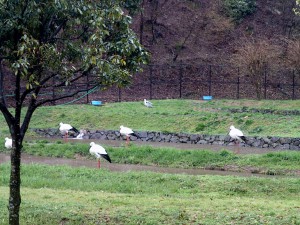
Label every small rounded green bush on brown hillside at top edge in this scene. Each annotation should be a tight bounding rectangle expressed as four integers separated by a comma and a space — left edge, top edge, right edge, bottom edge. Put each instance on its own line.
223, 0, 256, 22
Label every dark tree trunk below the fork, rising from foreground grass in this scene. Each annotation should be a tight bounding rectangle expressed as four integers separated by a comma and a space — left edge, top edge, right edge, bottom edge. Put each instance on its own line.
8, 140, 22, 225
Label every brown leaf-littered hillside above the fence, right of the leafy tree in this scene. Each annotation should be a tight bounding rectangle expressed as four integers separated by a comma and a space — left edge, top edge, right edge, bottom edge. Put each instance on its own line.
133, 0, 299, 64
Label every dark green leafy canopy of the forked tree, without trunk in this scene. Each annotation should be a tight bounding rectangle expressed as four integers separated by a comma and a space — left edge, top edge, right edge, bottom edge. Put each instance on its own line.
0, 0, 149, 93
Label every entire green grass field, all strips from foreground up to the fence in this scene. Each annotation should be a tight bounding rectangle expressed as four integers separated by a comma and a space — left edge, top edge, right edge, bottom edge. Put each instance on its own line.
0, 100, 300, 225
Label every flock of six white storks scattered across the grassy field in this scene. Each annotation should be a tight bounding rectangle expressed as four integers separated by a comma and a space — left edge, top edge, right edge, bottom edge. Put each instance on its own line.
4, 99, 246, 168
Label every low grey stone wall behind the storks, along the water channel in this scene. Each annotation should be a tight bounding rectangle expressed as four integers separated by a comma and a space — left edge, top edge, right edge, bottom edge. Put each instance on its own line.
33, 129, 300, 150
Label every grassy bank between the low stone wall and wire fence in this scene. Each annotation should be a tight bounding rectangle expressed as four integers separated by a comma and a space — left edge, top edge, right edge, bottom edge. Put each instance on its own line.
0, 100, 300, 137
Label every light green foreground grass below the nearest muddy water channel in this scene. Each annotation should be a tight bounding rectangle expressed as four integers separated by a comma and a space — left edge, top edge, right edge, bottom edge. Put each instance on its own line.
0, 164, 300, 224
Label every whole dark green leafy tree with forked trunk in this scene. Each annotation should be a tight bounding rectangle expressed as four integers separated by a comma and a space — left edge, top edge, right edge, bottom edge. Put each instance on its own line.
0, 0, 149, 224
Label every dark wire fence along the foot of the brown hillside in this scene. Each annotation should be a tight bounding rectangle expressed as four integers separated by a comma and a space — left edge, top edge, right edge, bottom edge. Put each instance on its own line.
2, 64, 300, 104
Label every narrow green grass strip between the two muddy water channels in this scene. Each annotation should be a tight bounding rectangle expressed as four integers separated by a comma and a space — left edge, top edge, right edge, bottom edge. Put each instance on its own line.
0, 140, 300, 175
